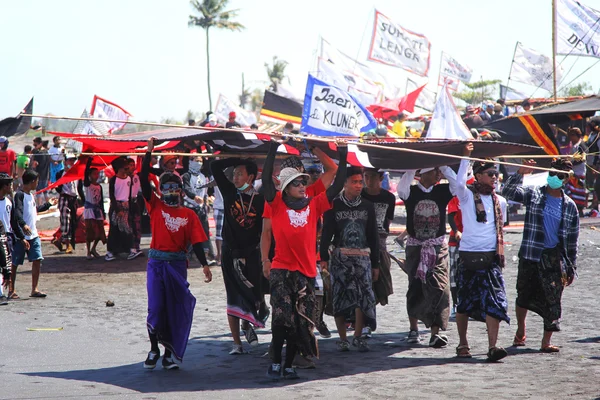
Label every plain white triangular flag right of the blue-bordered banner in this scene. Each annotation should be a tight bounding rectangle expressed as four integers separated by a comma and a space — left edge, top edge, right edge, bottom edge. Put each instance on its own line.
427, 86, 473, 140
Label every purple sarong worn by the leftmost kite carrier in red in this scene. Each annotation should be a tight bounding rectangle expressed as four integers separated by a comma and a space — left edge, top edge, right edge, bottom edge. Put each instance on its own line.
146, 258, 196, 361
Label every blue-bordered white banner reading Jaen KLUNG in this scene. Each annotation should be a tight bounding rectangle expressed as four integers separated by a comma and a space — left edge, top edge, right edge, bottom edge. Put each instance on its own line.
301, 75, 377, 136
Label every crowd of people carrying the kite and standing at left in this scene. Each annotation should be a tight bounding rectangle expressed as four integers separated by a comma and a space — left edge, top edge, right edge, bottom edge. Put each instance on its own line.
0, 126, 579, 379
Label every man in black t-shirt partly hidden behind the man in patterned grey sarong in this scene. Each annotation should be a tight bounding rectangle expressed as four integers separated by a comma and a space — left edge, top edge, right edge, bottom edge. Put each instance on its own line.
361, 168, 396, 310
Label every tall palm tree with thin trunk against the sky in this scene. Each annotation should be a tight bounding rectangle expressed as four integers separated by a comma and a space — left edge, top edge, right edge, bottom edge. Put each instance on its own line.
188, 0, 245, 110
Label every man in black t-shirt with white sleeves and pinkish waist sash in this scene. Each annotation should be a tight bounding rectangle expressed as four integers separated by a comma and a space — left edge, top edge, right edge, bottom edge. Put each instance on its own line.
398, 167, 456, 348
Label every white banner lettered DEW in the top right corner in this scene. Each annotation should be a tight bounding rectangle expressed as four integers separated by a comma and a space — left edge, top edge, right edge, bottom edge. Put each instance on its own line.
556, 0, 600, 58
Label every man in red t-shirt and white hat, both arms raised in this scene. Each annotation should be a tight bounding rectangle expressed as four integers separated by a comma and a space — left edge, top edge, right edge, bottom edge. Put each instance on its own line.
260, 142, 347, 379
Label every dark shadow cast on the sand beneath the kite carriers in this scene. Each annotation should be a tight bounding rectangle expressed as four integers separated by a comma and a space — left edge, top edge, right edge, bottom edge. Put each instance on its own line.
23, 333, 502, 393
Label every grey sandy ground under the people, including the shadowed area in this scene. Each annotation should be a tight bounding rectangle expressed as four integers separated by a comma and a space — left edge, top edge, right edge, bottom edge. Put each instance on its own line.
0, 221, 600, 399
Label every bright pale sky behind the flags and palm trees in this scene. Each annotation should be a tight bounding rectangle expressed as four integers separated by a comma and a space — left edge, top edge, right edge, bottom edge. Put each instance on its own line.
0, 0, 600, 120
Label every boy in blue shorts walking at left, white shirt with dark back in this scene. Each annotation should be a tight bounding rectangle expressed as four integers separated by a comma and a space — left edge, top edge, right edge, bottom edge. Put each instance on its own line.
9, 170, 57, 299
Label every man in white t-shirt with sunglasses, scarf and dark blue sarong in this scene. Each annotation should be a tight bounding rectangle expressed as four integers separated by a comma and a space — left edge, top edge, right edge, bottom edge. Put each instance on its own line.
455, 143, 510, 361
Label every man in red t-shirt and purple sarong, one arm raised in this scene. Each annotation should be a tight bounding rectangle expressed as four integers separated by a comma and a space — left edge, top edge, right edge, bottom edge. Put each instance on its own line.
140, 138, 212, 369
